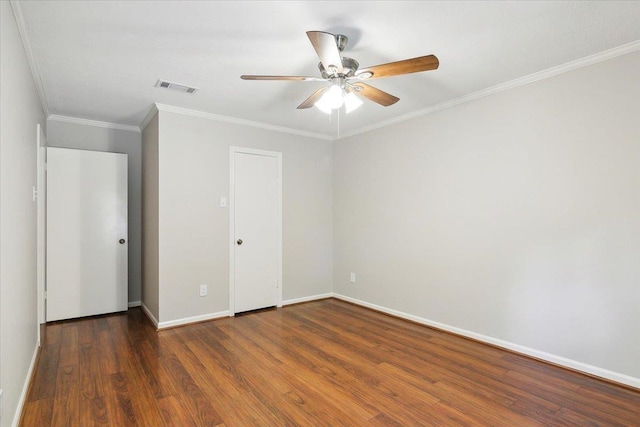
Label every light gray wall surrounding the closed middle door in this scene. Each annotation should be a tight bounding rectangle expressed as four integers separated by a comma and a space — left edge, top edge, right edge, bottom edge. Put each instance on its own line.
147, 111, 333, 322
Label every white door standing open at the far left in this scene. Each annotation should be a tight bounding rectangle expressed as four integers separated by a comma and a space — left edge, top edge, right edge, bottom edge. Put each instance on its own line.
46, 148, 128, 322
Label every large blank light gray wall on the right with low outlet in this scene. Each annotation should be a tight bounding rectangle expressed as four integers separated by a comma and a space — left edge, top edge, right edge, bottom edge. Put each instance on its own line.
333, 52, 640, 384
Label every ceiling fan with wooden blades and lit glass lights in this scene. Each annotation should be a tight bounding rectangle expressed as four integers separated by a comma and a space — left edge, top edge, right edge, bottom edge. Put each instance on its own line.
240, 31, 439, 113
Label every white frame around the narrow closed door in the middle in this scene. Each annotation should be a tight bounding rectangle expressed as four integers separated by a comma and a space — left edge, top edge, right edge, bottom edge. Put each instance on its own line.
229, 146, 282, 316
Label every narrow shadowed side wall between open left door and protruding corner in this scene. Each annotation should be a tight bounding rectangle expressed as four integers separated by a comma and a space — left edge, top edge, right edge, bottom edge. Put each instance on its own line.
142, 114, 160, 322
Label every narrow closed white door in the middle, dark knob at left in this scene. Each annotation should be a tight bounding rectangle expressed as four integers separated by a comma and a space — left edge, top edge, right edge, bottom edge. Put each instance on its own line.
231, 147, 282, 313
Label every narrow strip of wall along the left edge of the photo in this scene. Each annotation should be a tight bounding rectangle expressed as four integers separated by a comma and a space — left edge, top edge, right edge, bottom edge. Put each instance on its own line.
0, 1, 45, 427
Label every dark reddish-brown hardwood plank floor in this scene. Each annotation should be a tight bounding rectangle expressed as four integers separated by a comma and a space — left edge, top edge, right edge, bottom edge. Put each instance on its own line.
21, 299, 640, 427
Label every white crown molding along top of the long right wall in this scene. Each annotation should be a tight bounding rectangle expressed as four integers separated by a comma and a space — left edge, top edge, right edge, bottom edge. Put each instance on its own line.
335, 40, 640, 140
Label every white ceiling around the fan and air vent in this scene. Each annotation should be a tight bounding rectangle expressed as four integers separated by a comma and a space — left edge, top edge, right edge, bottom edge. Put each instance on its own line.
17, 1, 640, 137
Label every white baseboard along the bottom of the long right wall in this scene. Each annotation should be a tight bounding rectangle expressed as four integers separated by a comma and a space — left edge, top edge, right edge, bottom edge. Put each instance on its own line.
333, 293, 640, 389
